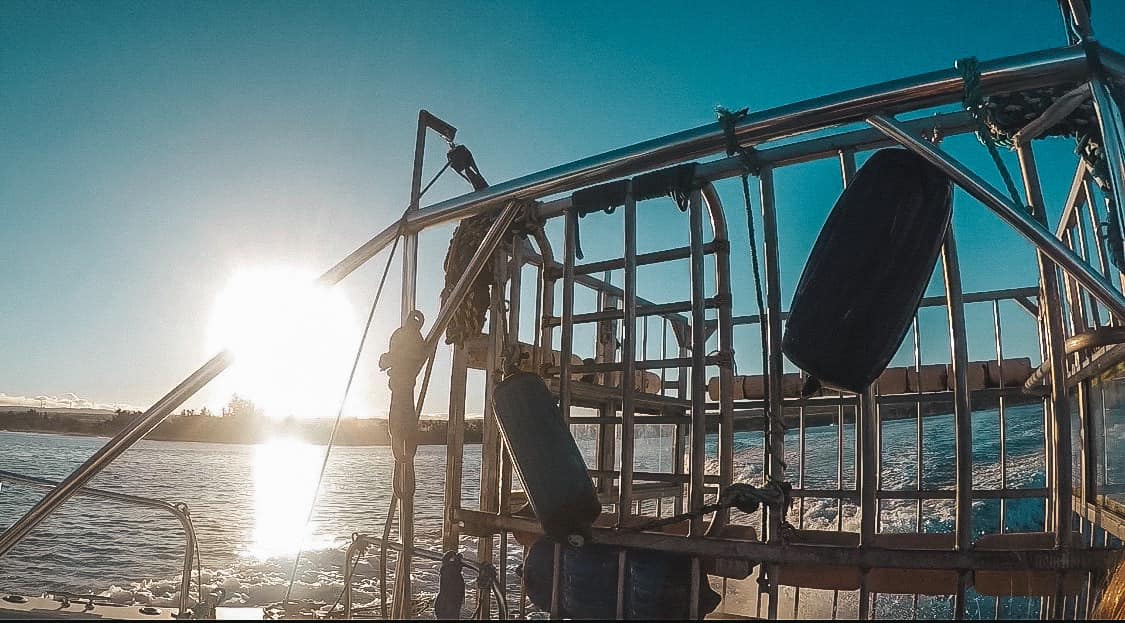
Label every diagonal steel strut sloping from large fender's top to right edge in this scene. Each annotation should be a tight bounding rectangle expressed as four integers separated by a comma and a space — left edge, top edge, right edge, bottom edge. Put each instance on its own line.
867, 115, 1125, 317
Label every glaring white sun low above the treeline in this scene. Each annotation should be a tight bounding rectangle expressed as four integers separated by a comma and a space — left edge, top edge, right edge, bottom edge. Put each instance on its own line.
208, 267, 360, 418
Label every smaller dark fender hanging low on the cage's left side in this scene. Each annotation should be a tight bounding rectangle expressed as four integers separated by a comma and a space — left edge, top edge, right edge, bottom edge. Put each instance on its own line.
493, 372, 602, 543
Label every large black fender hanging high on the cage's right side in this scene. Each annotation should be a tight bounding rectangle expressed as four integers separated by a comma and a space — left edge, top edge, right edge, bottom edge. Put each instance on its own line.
782, 148, 953, 392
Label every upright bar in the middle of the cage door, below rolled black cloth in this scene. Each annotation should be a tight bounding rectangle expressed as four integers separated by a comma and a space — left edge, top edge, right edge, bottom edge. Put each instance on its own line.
618, 180, 637, 524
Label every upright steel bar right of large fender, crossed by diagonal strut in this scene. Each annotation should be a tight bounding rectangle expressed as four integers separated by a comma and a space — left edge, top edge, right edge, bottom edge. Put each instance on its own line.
1016, 145, 1072, 549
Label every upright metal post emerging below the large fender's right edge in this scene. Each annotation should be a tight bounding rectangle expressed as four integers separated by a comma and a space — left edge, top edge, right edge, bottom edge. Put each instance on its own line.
942, 230, 973, 620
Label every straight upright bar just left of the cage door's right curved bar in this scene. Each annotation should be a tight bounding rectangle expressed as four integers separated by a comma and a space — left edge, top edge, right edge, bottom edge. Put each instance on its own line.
687, 191, 707, 536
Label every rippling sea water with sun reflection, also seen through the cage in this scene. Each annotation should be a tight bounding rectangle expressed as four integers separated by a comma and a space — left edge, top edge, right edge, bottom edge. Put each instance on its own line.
0, 405, 1098, 617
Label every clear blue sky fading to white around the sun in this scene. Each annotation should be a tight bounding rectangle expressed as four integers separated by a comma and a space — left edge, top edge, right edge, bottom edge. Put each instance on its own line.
0, 0, 1125, 413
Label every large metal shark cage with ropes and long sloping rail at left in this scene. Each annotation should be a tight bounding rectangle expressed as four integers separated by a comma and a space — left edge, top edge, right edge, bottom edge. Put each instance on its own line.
0, 1, 1125, 619
